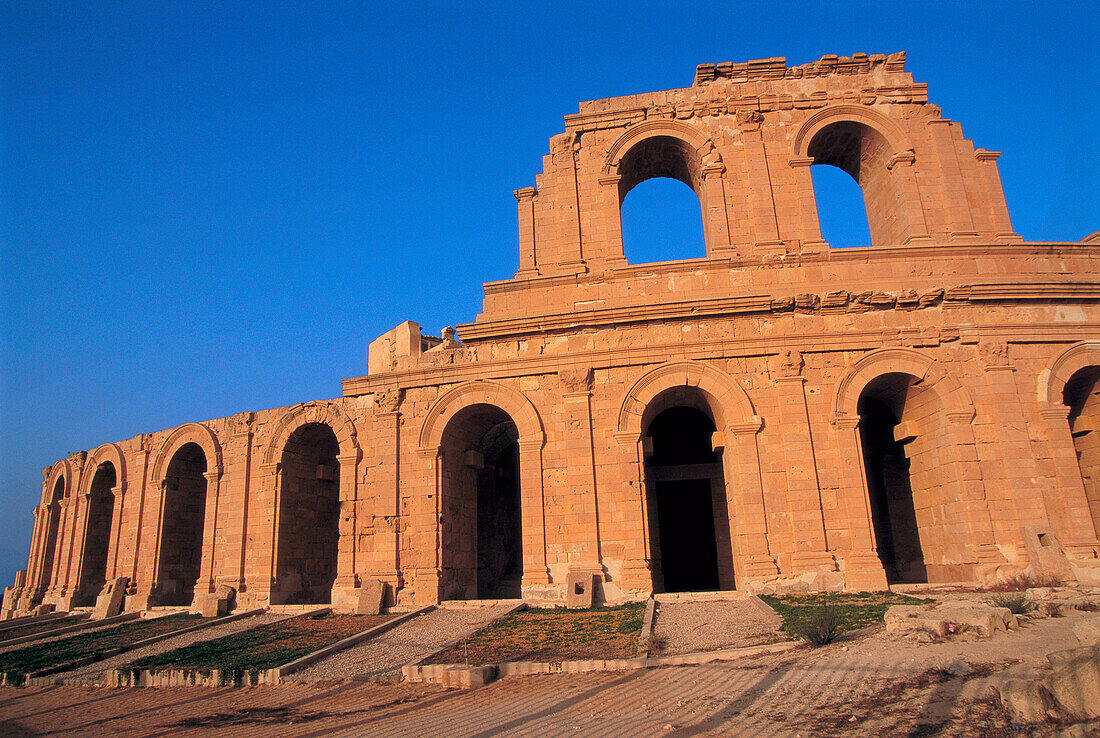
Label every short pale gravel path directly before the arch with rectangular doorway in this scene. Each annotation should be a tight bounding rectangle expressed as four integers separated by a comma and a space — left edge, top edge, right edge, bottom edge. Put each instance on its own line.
653, 599, 787, 656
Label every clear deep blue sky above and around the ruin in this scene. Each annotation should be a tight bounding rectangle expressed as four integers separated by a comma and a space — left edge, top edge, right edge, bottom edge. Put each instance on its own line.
0, 0, 1100, 585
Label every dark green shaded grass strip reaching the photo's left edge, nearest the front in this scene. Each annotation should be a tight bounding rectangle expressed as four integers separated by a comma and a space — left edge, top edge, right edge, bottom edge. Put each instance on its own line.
0, 615, 202, 683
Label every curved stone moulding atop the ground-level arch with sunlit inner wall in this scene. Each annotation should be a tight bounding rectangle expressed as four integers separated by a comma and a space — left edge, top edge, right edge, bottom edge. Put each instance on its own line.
833, 349, 975, 421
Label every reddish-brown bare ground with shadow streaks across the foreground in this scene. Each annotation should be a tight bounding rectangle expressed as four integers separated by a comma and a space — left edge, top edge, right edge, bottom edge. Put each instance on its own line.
0, 612, 1100, 738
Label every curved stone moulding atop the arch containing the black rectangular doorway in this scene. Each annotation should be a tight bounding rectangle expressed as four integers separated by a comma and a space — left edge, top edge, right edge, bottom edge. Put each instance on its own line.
615, 361, 760, 438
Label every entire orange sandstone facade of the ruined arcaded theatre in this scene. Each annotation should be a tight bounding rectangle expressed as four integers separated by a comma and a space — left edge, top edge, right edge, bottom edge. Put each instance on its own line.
4, 54, 1100, 614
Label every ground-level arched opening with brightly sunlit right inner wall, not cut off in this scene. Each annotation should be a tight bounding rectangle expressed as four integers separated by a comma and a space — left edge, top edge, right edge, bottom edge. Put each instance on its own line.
858, 373, 971, 583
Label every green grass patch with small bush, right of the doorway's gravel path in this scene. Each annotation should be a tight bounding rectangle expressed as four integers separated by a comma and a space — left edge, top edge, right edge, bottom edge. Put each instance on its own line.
760, 592, 935, 642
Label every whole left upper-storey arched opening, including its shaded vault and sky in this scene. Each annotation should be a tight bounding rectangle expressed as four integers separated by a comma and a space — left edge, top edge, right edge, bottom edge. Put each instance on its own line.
618, 136, 706, 264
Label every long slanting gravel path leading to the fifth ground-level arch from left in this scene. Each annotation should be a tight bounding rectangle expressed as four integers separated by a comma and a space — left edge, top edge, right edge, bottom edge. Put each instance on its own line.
287, 603, 514, 682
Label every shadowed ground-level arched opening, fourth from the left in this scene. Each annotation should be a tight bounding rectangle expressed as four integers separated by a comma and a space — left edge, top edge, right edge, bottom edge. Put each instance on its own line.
272, 422, 340, 604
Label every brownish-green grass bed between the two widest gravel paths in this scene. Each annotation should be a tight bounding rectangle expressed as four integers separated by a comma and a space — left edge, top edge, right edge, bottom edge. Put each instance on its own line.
425, 603, 646, 665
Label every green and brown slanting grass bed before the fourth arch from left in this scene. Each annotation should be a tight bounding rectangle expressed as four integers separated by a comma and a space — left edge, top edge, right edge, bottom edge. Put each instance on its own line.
127, 614, 393, 674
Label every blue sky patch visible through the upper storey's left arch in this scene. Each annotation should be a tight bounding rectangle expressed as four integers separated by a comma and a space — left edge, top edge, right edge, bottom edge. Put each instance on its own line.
619, 177, 706, 264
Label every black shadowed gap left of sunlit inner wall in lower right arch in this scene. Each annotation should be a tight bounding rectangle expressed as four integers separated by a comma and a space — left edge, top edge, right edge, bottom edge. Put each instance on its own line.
859, 374, 928, 584
